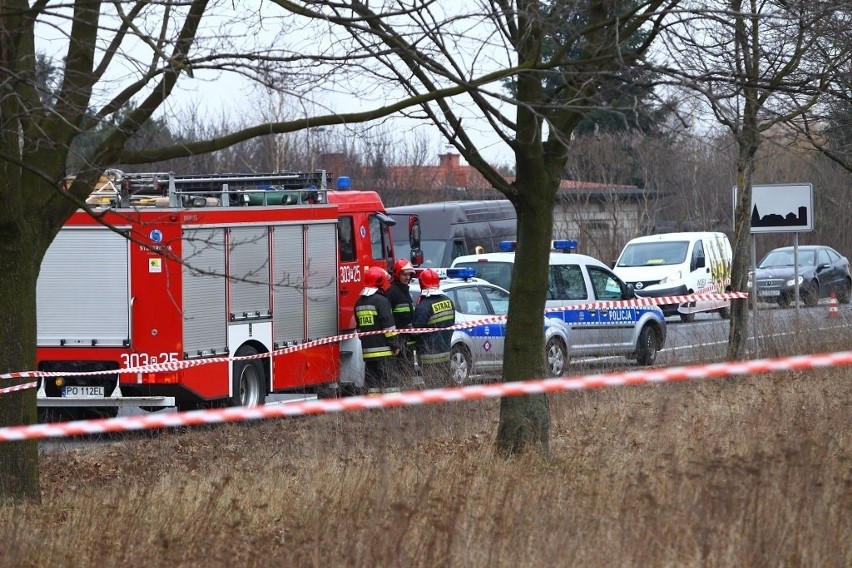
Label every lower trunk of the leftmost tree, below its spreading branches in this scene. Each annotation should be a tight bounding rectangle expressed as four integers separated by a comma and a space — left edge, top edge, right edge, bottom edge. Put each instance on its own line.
0, 223, 44, 504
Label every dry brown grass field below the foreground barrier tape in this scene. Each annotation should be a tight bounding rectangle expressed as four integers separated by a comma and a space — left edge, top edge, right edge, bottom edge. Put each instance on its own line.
0, 326, 852, 568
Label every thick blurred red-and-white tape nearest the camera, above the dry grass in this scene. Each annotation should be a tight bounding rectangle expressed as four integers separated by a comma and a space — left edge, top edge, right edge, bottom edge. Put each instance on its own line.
0, 351, 852, 442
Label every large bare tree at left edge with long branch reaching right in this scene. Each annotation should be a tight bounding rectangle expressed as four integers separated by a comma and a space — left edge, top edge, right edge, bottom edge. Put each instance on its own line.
0, 0, 503, 501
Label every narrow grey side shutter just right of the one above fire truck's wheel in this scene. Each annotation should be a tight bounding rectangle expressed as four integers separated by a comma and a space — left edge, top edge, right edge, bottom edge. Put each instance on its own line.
272, 225, 305, 345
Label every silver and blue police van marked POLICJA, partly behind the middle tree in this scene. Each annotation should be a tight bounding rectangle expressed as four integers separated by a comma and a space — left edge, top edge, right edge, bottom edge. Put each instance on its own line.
452, 241, 666, 365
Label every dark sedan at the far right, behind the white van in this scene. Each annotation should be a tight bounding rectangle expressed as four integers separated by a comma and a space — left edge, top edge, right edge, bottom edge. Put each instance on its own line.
755, 245, 852, 307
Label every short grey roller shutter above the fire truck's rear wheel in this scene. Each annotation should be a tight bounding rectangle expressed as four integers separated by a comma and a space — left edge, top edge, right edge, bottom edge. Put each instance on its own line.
228, 227, 270, 320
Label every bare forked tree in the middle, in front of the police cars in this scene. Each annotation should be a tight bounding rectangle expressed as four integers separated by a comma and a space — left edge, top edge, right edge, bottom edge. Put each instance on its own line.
258, 0, 679, 454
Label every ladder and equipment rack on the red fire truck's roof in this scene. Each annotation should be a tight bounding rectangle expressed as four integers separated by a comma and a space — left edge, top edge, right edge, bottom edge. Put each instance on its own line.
103, 170, 331, 211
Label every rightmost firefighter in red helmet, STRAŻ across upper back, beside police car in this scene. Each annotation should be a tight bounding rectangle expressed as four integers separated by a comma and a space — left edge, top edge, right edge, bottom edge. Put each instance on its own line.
413, 268, 456, 385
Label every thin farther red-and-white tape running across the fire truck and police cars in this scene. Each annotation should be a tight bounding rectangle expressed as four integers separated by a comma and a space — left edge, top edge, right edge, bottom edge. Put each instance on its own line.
0, 292, 748, 382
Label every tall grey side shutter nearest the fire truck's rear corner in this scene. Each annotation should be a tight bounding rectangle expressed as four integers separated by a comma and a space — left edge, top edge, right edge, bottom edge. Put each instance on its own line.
183, 229, 227, 357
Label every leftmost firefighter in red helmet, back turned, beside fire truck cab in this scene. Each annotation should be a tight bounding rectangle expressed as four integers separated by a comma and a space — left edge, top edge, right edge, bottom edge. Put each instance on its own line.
355, 266, 402, 393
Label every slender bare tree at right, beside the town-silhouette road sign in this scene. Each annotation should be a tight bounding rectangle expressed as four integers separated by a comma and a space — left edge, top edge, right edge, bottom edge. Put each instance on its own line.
664, 0, 849, 359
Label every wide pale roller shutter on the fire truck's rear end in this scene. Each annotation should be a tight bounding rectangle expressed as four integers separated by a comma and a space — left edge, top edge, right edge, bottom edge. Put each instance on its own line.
36, 227, 130, 346
